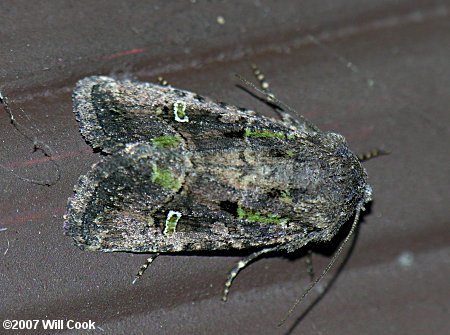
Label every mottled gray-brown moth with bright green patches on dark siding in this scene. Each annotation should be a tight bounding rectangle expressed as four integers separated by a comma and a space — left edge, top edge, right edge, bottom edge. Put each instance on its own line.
65, 68, 372, 320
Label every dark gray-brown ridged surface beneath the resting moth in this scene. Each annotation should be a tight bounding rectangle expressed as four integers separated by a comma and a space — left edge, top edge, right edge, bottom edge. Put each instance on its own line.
0, 1, 450, 334
